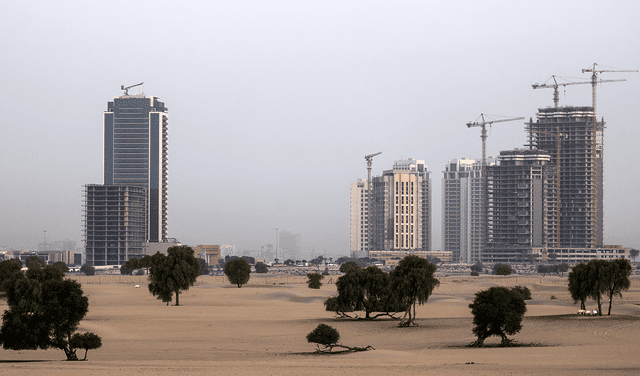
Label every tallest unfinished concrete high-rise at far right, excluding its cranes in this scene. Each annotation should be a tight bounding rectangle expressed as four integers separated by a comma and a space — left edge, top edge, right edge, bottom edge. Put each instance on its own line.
527, 107, 604, 248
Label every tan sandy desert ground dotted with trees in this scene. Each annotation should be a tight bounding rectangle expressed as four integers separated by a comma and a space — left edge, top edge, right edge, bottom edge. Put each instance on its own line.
0, 275, 640, 376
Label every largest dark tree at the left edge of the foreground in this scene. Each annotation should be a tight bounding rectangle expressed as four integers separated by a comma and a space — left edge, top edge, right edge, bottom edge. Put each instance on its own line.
0, 266, 100, 360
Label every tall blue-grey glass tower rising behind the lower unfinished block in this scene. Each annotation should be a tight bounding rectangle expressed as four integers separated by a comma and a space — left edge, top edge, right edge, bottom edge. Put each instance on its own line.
103, 93, 168, 242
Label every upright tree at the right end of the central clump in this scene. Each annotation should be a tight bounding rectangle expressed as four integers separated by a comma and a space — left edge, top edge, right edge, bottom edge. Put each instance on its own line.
390, 255, 440, 327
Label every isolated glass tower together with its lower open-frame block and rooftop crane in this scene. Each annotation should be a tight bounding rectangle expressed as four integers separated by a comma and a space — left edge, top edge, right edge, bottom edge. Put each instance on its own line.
83, 85, 168, 266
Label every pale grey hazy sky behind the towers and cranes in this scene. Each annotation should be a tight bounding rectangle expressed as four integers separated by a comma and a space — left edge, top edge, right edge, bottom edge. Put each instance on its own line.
0, 0, 640, 255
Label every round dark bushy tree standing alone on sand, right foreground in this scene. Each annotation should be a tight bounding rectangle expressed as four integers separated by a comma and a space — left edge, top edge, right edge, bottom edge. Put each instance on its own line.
469, 287, 527, 347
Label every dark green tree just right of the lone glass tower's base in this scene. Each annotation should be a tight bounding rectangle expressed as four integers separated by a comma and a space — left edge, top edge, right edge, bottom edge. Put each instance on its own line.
149, 246, 200, 306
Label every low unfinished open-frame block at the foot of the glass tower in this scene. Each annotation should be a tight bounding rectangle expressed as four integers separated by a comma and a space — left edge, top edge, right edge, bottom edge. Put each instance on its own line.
83, 184, 148, 266
